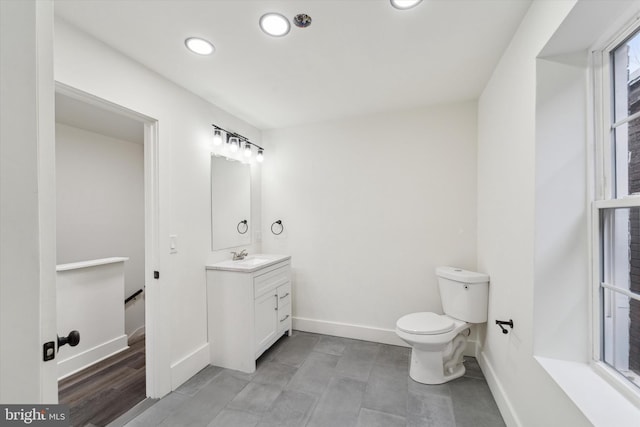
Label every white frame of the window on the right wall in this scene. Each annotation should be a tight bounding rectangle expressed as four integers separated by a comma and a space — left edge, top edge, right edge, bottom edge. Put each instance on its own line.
587, 19, 640, 406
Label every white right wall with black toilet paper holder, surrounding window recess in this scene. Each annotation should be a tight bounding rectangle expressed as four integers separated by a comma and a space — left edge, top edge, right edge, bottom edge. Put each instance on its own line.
478, 1, 590, 427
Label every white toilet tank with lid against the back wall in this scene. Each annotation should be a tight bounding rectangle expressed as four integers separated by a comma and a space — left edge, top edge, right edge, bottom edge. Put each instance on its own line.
436, 267, 489, 323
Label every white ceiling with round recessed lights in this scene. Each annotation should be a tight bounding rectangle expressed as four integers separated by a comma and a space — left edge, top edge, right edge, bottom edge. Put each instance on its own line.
55, 0, 531, 129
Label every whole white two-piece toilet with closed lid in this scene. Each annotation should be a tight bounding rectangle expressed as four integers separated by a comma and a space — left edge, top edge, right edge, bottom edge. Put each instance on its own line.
396, 267, 489, 384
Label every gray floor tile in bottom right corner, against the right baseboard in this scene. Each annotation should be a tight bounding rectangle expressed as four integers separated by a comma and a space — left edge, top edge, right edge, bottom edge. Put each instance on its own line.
448, 377, 505, 427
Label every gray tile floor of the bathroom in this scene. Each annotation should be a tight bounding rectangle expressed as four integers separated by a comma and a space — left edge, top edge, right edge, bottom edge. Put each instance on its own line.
126, 331, 505, 427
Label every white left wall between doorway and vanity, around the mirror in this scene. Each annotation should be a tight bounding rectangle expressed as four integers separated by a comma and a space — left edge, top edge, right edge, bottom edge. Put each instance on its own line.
55, 20, 260, 397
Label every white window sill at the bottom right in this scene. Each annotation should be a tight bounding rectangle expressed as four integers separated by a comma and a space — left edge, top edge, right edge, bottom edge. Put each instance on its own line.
535, 356, 640, 427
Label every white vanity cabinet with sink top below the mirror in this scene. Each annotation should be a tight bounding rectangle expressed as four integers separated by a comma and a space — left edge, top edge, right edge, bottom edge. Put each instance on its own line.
206, 255, 291, 373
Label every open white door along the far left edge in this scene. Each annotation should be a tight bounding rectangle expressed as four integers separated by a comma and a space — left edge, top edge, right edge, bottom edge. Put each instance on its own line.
0, 0, 58, 404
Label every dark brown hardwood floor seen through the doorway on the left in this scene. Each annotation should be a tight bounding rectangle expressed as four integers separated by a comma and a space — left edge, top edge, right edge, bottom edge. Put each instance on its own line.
58, 335, 146, 427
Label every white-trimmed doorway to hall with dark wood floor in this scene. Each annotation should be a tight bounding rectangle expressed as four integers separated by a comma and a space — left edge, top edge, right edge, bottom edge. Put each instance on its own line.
56, 83, 157, 426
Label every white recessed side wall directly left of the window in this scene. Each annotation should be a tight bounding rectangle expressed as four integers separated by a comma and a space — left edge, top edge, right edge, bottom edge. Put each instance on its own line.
533, 55, 590, 362
